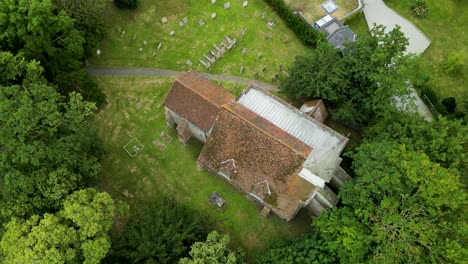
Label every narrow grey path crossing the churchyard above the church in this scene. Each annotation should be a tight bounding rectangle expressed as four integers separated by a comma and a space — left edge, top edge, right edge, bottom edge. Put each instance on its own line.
86, 67, 279, 91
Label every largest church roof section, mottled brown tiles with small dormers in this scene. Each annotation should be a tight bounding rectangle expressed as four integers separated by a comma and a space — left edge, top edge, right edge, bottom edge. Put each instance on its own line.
198, 102, 317, 220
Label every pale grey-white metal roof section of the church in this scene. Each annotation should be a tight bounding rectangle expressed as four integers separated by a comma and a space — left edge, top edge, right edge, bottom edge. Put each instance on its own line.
238, 87, 348, 182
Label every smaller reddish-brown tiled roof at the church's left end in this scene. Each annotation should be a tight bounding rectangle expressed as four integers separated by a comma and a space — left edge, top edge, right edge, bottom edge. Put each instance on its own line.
164, 71, 235, 132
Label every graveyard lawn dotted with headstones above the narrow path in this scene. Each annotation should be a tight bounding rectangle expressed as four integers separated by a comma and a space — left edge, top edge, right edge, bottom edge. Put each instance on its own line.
90, 0, 308, 82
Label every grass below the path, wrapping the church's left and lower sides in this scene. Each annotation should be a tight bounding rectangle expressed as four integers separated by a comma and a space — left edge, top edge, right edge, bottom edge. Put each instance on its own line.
92, 76, 311, 259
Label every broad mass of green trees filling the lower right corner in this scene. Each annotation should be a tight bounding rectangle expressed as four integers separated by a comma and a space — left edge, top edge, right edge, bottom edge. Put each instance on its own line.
258, 116, 468, 263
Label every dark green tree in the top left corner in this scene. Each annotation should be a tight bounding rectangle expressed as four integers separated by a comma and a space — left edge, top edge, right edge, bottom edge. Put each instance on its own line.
0, 0, 84, 80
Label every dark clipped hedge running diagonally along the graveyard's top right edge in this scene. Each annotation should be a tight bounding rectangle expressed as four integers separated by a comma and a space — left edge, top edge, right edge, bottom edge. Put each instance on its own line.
265, 0, 325, 48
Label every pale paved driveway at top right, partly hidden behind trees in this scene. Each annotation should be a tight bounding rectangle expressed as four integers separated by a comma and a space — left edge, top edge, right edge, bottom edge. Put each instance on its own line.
363, 0, 433, 121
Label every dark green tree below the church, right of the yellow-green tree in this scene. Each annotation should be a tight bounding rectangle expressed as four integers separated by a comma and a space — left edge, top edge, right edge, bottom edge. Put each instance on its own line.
108, 198, 208, 263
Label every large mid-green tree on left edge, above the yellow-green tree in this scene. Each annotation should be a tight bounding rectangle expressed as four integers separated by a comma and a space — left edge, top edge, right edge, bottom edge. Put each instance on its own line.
0, 77, 101, 220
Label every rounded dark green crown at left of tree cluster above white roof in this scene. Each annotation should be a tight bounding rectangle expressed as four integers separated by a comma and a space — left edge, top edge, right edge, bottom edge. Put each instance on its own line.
281, 42, 348, 103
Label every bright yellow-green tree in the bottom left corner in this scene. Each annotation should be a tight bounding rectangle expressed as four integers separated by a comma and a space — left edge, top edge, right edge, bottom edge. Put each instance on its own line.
0, 189, 114, 264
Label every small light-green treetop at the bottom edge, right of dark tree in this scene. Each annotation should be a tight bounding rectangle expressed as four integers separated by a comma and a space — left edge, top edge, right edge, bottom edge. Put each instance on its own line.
179, 231, 244, 264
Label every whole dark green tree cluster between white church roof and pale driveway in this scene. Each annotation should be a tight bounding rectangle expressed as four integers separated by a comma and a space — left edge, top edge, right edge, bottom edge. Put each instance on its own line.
281, 26, 419, 123
